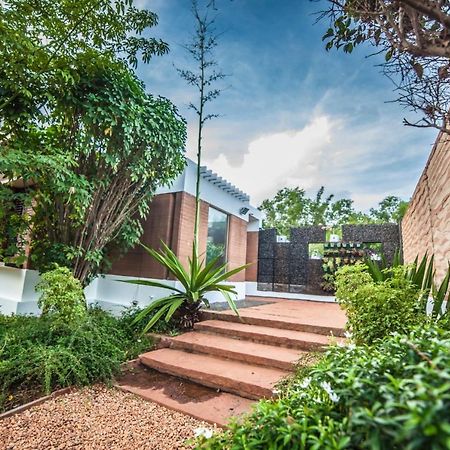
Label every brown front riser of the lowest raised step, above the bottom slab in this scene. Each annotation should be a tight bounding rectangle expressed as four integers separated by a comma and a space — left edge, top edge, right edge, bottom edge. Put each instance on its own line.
140, 356, 273, 400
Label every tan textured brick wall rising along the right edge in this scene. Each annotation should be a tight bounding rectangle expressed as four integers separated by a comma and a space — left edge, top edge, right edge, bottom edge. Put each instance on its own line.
402, 133, 450, 282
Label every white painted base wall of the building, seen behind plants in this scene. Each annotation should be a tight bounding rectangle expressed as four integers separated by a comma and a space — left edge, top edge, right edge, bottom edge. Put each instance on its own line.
0, 266, 246, 315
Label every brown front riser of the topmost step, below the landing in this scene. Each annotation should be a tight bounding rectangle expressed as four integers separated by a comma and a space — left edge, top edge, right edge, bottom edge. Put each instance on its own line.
200, 311, 344, 337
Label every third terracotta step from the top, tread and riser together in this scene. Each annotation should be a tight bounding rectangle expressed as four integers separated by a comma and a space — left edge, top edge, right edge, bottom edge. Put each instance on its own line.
169, 331, 306, 370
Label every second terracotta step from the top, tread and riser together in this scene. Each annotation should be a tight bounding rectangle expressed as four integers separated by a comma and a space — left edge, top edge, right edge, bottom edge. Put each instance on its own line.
194, 320, 343, 351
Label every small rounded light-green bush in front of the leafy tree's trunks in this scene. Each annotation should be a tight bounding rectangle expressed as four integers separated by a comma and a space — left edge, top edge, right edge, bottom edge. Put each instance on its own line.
36, 266, 86, 326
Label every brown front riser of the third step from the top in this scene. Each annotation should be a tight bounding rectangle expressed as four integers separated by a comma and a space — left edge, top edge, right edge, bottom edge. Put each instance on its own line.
170, 340, 294, 370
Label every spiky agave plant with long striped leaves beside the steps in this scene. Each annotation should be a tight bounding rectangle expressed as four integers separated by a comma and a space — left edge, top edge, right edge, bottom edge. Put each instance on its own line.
125, 241, 250, 333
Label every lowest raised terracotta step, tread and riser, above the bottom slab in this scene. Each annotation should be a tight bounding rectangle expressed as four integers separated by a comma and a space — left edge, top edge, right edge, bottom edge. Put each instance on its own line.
140, 348, 289, 400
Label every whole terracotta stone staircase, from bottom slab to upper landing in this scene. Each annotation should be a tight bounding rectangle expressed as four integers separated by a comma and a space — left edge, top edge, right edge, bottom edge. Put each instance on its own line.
120, 301, 345, 426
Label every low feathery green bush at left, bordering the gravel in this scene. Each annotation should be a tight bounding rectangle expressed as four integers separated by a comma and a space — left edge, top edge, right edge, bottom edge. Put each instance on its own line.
0, 308, 151, 411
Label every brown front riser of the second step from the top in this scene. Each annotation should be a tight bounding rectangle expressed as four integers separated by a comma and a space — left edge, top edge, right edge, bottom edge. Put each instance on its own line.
194, 322, 326, 352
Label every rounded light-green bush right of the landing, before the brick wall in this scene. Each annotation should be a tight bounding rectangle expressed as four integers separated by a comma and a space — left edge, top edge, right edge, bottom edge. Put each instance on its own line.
336, 264, 427, 344
